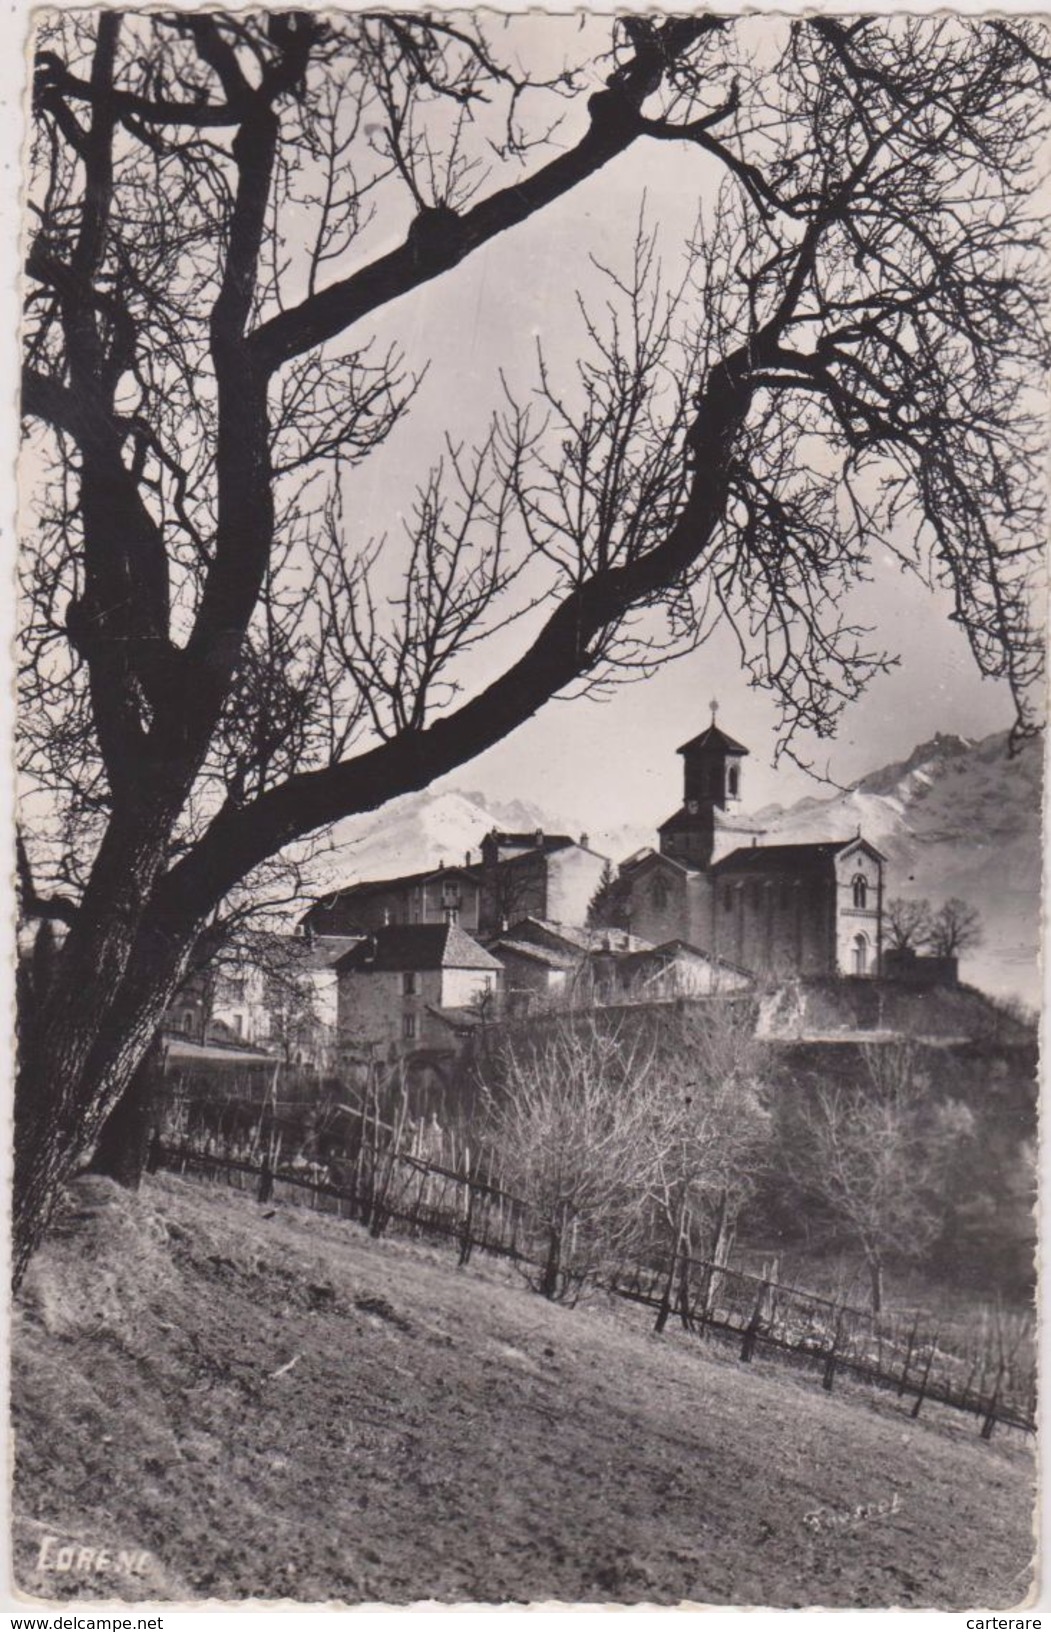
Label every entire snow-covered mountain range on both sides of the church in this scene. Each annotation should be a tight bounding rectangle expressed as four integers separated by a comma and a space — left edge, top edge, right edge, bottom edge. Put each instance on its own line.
303, 733, 1043, 1004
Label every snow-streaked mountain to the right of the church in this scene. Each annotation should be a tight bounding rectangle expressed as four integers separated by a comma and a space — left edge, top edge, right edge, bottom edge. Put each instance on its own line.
757, 733, 1043, 1005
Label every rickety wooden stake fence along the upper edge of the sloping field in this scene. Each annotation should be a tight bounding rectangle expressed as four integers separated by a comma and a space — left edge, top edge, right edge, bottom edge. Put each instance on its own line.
149, 1139, 1036, 1439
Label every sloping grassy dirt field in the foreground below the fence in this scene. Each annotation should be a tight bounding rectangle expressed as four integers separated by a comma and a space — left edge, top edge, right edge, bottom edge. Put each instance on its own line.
13, 1177, 1033, 1608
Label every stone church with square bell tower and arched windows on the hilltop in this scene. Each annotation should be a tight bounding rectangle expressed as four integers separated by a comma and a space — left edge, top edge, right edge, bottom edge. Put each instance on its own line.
620, 705, 885, 979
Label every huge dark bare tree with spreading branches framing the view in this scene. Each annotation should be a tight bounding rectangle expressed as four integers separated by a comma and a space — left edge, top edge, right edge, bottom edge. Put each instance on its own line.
15, 11, 1048, 1278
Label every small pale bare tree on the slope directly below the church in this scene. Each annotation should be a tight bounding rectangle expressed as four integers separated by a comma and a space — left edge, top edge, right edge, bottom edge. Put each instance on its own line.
796, 1043, 973, 1314
